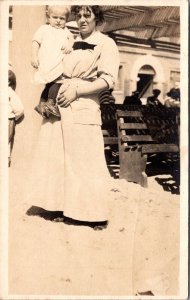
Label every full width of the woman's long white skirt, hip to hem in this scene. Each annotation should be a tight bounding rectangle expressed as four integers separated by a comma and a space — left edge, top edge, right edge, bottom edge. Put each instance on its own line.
27, 107, 111, 221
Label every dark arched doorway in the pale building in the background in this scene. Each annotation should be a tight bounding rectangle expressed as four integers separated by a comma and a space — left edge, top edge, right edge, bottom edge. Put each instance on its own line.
137, 65, 156, 98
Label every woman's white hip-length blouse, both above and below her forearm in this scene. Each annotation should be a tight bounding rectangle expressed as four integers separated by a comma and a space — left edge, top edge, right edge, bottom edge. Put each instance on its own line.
59, 31, 119, 125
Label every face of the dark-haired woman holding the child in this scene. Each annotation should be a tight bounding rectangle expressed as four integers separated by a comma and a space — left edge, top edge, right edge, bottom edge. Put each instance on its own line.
76, 8, 96, 37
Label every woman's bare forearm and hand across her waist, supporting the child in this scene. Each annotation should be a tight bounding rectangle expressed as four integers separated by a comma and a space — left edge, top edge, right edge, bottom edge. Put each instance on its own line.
57, 78, 108, 107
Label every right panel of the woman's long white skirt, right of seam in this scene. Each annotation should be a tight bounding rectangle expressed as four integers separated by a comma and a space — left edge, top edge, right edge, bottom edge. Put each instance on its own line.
60, 107, 111, 221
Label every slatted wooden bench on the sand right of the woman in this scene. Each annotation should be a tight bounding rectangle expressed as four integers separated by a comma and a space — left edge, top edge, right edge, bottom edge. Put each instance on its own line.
102, 105, 179, 187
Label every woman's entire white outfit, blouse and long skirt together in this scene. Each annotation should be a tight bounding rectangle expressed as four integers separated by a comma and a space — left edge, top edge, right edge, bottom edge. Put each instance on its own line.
26, 31, 119, 221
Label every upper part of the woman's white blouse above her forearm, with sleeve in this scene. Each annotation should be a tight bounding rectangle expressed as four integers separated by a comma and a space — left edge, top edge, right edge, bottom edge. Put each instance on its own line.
63, 31, 119, 88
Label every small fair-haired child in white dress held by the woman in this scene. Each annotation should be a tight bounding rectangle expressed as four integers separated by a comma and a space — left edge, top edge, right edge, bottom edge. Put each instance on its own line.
31, 5, 74, 118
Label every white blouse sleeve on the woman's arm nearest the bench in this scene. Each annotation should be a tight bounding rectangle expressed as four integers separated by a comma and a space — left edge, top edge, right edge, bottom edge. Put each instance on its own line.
97, 37, 120, 89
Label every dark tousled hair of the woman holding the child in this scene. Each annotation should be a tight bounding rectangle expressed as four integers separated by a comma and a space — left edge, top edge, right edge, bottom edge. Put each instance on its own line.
71, 5, 104, 25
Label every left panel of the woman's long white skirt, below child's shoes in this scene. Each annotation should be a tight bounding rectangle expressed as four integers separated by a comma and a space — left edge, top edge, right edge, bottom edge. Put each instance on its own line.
25, 119, 64, 211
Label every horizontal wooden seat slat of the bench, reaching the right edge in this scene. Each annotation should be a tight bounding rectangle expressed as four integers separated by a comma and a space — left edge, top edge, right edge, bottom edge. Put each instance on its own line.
142, 144, 179, 153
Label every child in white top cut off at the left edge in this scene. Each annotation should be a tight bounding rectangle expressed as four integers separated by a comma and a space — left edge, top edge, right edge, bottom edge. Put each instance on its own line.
8, 70, 24, 167
